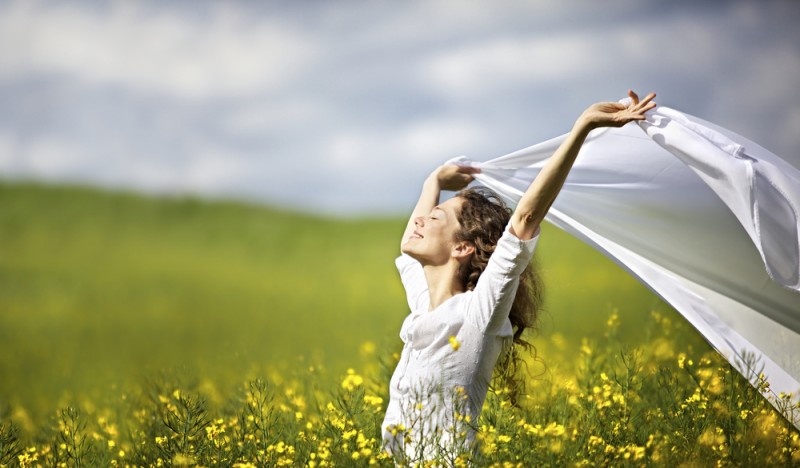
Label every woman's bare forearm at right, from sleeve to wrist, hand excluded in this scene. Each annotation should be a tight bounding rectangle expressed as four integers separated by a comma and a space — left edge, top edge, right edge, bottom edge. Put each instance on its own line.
511, 119, 592, 239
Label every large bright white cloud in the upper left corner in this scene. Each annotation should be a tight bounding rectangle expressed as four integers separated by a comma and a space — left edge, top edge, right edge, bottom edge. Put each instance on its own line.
0, 2, 316, 98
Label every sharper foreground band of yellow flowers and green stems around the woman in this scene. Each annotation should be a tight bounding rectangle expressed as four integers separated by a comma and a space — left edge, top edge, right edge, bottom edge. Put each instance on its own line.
0, 313, 800, 467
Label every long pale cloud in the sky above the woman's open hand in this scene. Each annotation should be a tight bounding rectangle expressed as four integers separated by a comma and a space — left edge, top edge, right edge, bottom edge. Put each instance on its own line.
422, 18, 744, 100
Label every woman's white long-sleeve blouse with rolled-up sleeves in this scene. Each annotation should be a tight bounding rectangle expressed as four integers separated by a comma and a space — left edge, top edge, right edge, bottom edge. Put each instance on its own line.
382, 221, 539, 457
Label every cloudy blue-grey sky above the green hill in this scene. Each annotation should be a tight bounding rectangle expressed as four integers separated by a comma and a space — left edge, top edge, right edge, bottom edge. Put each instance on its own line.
0, 0, 800, 216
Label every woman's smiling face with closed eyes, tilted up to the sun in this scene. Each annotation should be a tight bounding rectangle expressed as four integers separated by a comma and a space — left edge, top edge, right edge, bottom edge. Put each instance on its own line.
401, 197, 464, 265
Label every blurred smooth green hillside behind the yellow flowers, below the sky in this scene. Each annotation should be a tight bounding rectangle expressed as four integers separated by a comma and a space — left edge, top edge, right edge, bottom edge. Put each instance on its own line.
0, 182, 666, 418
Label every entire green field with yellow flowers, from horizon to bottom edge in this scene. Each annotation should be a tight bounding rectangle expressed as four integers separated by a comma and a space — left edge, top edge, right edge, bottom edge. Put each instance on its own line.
0, 184, 800, 467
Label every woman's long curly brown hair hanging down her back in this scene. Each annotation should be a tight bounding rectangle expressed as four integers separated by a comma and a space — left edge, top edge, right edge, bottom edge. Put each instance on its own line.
456, 187, 543, 405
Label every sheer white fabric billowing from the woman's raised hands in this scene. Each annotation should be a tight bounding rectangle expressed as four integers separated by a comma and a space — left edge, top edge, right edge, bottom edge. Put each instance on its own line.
451, 106, 800, 428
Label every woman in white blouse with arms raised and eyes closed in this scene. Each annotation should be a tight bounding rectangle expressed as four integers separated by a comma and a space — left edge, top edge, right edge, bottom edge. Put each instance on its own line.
383, 91, 656, 462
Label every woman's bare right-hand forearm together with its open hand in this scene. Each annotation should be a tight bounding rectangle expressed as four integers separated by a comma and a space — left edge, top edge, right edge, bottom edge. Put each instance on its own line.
511, 91, 656, 239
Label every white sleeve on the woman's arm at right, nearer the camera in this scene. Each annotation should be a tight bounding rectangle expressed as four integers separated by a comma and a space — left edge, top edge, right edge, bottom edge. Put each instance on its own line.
466, 223, 541, 334
